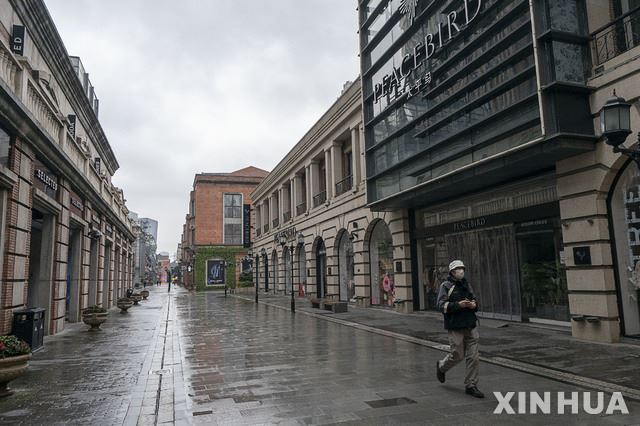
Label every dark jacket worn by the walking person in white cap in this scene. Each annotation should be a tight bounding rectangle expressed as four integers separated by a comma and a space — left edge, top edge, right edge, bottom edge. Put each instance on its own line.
438, 276, 478, 330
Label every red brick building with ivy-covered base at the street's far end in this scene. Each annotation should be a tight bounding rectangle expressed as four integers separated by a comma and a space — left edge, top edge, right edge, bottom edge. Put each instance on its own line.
178, 167, 268, 290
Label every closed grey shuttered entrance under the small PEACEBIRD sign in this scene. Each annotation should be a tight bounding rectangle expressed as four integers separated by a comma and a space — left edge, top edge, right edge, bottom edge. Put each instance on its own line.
445, 225, 522, 321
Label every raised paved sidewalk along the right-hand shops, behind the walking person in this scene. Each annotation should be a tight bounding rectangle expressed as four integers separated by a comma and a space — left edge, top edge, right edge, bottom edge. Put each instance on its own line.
234, 292, 640, 401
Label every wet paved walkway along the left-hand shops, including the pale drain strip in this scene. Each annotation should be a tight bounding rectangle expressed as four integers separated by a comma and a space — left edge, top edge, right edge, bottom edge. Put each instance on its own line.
0, 285, 187, 425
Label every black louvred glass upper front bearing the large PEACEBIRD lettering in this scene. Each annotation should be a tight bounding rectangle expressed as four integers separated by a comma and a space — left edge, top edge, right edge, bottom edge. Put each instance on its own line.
360, 0, 593, 209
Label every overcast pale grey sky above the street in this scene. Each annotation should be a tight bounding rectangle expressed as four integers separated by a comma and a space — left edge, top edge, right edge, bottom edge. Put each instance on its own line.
45, 0, 359, 255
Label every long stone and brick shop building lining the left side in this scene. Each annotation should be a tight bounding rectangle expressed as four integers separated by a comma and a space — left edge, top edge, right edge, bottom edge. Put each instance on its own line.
0, 0, 134, 334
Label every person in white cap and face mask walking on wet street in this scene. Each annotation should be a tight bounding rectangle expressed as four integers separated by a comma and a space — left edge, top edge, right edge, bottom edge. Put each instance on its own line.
436, 260, 484, 398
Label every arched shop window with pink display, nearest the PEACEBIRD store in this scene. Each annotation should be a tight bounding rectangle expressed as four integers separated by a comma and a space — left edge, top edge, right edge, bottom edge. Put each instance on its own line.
369, 221, 395, 306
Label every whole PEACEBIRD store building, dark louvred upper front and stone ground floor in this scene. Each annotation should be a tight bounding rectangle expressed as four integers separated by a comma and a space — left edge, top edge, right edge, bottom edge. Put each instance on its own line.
359, 0, 640, 342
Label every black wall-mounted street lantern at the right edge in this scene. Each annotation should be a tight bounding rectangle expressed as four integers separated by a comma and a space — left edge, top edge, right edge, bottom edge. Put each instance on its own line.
600, 90, 640, 168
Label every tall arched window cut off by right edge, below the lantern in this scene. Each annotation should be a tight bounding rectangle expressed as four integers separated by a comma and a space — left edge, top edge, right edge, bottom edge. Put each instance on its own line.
610, 162, 640, 336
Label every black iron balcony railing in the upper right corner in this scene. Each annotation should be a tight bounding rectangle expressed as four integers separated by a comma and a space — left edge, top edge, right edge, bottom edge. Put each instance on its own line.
591, 7, 640, 66
